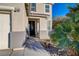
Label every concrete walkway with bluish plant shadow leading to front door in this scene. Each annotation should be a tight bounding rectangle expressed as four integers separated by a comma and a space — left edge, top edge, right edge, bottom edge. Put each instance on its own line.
24, 37, 50, 56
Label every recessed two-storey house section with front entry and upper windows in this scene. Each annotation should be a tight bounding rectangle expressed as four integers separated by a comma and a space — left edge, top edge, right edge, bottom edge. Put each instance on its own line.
25, 3, 52, 40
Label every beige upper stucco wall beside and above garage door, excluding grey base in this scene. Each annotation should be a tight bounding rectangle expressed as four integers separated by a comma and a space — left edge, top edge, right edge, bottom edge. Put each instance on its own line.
0, 3, 28, 32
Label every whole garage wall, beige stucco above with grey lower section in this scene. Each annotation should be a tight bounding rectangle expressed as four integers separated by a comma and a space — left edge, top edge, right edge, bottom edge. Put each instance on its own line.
0, 3, 28, 48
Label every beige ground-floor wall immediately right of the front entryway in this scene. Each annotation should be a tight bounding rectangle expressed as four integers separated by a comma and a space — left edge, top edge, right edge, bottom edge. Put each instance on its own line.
40, 18, 49, 39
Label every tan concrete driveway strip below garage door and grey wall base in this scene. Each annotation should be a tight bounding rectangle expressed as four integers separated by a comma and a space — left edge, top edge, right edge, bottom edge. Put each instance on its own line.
0, 48, 24, 56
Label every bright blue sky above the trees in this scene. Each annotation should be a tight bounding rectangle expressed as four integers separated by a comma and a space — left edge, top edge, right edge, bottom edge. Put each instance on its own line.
52, 3, 75, 17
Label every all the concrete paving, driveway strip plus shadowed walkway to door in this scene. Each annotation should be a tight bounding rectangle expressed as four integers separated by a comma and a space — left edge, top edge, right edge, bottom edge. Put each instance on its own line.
0, 37, 50, 56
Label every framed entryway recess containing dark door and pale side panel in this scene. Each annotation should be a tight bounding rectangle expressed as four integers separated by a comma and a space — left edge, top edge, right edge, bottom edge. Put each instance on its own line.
28, 18, 40, 38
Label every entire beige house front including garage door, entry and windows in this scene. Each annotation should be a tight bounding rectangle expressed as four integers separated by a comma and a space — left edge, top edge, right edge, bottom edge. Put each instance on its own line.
0, 3, 52, 49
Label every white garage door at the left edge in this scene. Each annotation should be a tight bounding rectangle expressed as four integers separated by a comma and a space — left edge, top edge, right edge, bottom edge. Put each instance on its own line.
0, 14, 10, 49
